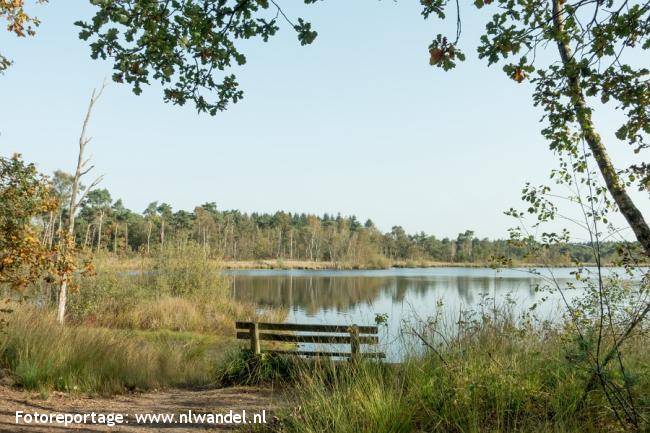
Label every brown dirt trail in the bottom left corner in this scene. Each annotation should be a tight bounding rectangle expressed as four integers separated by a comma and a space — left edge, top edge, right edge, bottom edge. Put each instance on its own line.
0, 386, 286, 433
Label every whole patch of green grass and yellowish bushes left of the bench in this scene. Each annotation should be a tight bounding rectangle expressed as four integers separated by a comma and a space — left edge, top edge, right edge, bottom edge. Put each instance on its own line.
0, 242, 285, 394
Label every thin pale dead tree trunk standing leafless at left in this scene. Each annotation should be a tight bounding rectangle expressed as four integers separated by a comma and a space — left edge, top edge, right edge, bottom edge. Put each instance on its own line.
56, 84, 106, 324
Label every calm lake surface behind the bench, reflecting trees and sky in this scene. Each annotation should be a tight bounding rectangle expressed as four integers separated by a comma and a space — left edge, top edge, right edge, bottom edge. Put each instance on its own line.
228, 268, 628, 360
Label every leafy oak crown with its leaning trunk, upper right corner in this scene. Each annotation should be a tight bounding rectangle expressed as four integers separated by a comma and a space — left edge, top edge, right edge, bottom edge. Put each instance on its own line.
421, 0, 650, 256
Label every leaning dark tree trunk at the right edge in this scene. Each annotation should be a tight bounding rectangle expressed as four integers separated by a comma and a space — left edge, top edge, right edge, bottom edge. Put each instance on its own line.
553, 0, 650, 257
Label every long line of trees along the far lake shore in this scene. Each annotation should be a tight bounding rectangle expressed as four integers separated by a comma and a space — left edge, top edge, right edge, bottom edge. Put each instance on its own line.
38, 171, 617, 266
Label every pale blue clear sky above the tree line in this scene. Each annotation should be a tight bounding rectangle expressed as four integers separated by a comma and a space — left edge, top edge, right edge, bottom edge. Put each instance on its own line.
0, 0, 650, 238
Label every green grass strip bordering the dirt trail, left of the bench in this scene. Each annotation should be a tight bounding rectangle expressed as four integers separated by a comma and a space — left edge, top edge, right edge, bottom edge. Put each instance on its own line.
0, 307, 215, 394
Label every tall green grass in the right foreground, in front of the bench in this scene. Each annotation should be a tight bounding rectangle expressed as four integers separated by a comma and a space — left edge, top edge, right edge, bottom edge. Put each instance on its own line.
230, 317, 650, 433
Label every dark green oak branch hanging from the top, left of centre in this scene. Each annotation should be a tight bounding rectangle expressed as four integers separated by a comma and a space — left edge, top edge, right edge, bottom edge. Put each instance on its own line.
76, 0, 317, 115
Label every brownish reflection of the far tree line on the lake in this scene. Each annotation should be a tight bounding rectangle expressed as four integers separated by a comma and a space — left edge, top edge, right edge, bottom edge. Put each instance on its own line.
232, 269, 541, 317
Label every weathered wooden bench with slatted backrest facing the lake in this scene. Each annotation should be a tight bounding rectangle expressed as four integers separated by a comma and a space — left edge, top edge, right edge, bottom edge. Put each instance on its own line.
235, 322, 386, 358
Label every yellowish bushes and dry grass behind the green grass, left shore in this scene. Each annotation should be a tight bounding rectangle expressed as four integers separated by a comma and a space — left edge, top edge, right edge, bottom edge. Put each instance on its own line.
68, 242, 285, 330
